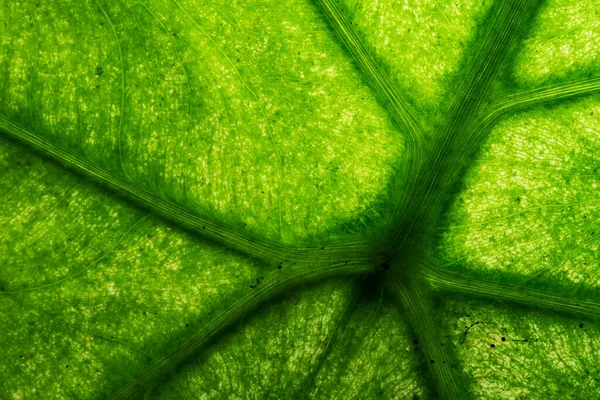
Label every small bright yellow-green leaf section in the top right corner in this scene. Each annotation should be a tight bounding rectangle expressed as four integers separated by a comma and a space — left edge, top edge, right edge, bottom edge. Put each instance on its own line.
513, 0, 600, 87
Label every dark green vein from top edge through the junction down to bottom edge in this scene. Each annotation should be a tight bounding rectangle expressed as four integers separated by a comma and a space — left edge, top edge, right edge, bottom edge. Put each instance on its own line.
385, 0, 538, 399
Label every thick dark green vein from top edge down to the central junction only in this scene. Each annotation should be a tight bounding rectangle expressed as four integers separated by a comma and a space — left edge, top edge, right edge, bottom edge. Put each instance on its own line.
388, 0, 540, 258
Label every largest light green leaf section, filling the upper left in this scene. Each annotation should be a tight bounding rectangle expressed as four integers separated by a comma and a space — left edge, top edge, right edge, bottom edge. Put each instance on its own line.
0, 0, 402, 243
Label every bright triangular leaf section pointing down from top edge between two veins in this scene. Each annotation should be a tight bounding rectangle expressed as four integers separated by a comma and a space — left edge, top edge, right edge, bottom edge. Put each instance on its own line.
343, 0, 491, 113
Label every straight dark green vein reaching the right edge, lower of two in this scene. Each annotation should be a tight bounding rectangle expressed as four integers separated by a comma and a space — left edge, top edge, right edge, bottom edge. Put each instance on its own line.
422, 266, 600, 318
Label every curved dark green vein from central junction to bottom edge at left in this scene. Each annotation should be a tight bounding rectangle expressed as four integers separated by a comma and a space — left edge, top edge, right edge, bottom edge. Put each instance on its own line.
110, 263, 371, 400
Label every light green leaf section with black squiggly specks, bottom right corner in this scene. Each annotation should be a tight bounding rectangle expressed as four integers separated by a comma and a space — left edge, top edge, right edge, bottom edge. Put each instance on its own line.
442, 300, 600, 399
